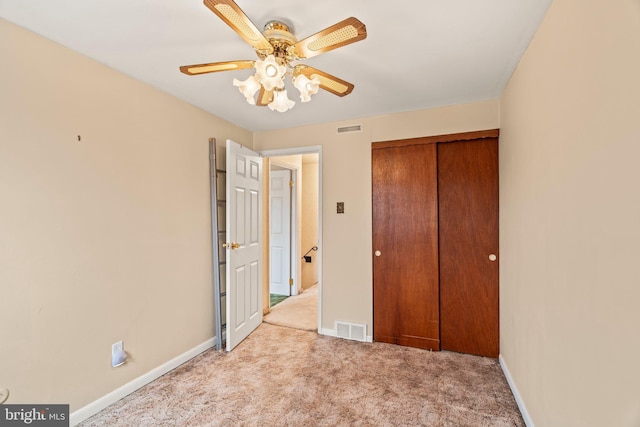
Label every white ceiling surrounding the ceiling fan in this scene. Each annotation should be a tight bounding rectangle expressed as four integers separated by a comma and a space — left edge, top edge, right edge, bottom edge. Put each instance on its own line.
0, 0, 552, 131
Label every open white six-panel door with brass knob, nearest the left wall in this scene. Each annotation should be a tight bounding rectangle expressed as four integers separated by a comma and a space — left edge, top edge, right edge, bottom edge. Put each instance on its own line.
225, 140, 262, 351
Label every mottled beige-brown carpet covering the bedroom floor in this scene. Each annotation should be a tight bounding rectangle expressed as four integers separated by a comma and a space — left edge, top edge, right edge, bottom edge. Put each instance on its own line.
81, 324, 525, 427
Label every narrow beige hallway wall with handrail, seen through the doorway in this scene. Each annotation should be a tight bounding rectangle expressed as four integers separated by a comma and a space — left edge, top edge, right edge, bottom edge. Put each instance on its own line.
300, 154, 319, 289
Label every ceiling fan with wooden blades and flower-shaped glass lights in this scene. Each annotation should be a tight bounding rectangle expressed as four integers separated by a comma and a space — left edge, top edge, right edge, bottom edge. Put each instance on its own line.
180, 0, 367, 112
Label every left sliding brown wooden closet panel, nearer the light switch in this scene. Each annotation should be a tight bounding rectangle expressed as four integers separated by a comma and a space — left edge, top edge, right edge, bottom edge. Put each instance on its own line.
371, 144, 440, 350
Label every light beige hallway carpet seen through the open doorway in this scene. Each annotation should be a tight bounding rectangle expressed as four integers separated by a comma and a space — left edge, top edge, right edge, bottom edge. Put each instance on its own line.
264, 285, 318, 331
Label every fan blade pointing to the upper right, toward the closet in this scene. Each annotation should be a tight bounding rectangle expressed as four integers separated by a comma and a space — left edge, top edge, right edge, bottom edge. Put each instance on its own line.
292, 17, 367, 58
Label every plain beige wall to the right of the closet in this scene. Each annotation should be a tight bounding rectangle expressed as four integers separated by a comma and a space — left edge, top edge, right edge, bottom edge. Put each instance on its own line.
500, 0, 640, 427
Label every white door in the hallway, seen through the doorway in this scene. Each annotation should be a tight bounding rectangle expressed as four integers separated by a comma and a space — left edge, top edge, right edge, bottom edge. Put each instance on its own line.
269, 170, 293, 295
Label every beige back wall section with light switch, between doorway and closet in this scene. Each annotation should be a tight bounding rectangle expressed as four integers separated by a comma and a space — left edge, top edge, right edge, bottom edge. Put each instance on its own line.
254, 101, 499, 335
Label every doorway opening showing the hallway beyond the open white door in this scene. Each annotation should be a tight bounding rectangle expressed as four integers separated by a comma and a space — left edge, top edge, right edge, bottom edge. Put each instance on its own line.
261, 147, 322, 331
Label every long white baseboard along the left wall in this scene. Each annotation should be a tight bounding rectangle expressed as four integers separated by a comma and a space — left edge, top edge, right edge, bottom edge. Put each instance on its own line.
69, 337, 216, 426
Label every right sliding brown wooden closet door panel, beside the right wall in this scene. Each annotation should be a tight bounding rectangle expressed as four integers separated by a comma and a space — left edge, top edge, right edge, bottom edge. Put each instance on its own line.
438, 138, 500, 357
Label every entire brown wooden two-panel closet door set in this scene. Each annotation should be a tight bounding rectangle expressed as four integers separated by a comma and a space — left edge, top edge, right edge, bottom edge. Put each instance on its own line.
372, 130, 499, 357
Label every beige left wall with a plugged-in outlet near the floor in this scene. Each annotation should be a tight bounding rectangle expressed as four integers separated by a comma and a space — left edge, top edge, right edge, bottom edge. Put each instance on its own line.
0, 19, 252, 411
